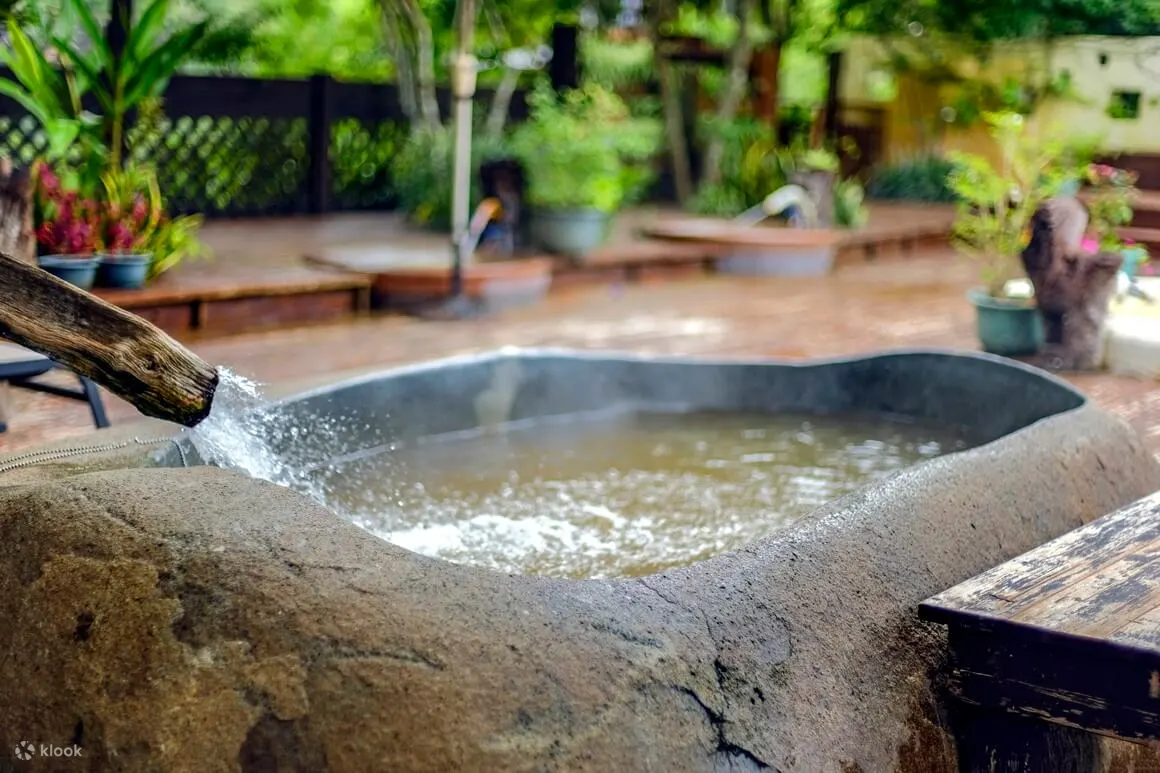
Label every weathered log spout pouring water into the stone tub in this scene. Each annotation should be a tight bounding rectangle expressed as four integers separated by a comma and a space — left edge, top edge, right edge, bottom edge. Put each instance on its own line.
0, 253, 218, 427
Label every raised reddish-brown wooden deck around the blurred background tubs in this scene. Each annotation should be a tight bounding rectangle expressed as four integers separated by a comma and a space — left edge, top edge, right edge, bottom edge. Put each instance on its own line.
79, 204, 950, 335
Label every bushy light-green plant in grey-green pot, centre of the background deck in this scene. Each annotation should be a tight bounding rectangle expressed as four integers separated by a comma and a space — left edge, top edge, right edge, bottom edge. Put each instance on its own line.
512, 85, 660, 258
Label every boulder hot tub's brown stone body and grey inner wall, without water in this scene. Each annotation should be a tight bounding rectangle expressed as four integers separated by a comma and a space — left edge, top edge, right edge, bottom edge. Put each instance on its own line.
0, 352, 1160, 773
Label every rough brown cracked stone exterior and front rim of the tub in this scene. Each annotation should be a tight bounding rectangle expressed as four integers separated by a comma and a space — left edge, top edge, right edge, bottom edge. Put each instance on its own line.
0, 383, 1160, 773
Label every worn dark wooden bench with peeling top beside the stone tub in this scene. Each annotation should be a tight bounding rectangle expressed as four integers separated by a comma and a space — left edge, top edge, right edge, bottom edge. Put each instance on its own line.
919, 492, 1160, 773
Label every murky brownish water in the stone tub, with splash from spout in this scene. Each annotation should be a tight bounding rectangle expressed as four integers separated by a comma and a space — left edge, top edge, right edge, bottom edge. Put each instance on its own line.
190, 373, 970, 578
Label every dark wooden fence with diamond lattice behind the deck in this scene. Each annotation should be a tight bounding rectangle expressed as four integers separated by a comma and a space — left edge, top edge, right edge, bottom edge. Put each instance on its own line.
0, 75, 527, 217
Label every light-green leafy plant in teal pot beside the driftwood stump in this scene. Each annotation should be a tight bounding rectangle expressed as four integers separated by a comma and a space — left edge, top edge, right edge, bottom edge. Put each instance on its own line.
947, 113, 1072, 356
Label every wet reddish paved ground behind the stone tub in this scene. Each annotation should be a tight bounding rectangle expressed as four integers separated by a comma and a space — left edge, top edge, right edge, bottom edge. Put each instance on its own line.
0, 250, 1160, 455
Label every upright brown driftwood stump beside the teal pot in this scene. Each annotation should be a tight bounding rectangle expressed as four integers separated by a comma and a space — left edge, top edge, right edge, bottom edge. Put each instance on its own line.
1023, 196, 1124, 370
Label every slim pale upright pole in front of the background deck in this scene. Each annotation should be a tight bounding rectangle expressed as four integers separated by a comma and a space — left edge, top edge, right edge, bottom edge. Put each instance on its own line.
451, 0, 478, 298
